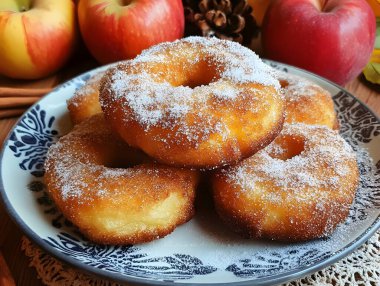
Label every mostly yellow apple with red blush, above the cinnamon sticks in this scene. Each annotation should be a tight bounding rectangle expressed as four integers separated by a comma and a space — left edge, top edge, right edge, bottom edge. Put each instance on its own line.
0, 0, 76, 79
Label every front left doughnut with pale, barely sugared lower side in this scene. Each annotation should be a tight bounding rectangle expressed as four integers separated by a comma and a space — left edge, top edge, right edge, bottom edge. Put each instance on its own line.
45, 114, 198, 244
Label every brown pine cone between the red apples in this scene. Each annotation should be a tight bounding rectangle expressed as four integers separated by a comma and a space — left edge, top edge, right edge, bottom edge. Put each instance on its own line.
183, 0, 259, 46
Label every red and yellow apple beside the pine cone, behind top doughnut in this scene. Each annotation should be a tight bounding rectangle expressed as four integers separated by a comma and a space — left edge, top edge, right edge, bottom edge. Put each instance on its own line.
78, 0, 184, 63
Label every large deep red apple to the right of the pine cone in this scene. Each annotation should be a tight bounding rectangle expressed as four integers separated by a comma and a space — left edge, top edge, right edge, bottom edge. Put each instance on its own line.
262, 0, 376, 85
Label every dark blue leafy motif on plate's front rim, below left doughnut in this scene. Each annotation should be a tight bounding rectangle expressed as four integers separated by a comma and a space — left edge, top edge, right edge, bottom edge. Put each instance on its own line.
45, 232, 217, 281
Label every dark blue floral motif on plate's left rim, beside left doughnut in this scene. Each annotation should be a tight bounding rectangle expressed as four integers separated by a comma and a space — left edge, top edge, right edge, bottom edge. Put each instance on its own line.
9, 104, 58, 177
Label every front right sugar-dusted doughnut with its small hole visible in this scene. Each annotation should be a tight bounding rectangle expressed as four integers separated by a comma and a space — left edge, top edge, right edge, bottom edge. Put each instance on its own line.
213, 124, 359, 241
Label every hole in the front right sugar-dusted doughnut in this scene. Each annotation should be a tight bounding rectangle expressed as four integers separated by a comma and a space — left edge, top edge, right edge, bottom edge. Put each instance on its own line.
269, 135, 305, 161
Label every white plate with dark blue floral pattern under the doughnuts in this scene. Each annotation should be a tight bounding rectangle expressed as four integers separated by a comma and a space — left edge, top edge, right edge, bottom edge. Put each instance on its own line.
0, 62, 380, 285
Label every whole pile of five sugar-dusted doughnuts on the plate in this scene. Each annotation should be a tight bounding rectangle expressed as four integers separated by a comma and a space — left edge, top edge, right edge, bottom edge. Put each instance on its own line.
45, 37, 359, 244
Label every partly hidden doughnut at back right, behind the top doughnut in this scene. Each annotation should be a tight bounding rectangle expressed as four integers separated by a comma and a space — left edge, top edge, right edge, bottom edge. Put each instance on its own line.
277, 72, 339, 129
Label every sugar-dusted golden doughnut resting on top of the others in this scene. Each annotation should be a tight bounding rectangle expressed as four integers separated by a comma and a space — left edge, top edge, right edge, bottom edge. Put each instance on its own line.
99, 37, 284, 168
